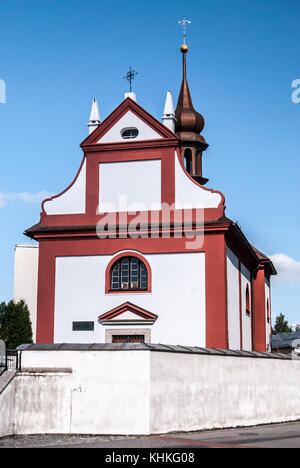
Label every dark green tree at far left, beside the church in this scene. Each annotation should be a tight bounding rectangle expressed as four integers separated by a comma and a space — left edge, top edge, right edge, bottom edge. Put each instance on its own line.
0, 301, 32, 349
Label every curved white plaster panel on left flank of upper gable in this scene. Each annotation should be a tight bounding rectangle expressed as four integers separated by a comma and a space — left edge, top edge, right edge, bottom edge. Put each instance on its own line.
44, 161, 86, 215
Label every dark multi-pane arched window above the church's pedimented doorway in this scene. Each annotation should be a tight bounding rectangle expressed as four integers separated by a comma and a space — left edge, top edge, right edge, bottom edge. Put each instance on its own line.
110, 256, 148, 291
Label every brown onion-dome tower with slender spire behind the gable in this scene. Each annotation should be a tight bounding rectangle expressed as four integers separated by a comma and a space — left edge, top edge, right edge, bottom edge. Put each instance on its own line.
175, 43, 208, 185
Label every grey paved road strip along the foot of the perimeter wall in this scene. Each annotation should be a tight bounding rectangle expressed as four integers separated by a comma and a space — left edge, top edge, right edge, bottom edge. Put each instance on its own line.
0, 422, 300, 449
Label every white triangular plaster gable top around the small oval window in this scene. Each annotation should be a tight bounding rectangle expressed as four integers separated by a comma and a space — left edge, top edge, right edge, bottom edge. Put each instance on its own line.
98, 110, 161, 143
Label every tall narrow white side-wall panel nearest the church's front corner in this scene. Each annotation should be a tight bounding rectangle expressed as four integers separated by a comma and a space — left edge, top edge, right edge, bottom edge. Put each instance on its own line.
227, 249, 241, 349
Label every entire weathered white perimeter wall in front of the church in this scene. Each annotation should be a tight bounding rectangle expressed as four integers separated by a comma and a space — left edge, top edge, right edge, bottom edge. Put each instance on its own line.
0, 350, 300, 436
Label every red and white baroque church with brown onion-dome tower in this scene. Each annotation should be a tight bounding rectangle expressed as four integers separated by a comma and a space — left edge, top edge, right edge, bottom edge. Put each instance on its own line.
25, 43, 276, 352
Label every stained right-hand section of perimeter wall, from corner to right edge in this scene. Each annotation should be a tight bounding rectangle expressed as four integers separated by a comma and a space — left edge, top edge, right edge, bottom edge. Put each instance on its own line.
150, 352, 300, 433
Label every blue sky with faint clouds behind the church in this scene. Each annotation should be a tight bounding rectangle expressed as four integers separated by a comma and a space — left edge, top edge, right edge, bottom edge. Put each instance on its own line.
0, 0, 300, 322
